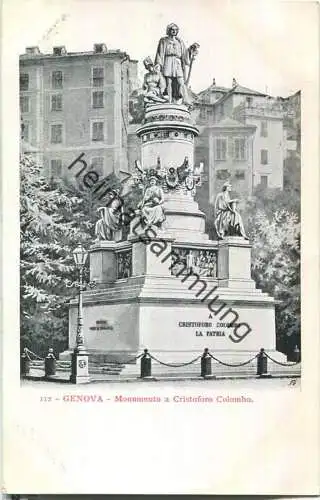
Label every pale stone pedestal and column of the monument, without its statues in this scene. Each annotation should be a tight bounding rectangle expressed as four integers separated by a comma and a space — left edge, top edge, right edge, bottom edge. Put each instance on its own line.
63, 104, 284, 375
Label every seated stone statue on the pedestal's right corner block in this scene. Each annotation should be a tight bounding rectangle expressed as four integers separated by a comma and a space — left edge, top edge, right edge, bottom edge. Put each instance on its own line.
214, 182, 248, 240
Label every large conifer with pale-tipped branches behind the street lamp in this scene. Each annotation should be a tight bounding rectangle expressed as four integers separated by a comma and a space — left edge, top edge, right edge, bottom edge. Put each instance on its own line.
20, 155, 93, 355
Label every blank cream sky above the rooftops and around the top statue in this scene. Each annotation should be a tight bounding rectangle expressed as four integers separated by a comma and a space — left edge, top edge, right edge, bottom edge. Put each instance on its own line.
3, 0, 319, 96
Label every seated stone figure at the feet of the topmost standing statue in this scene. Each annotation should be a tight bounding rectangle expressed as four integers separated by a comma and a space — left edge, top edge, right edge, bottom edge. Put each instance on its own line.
142, 57, 168, 104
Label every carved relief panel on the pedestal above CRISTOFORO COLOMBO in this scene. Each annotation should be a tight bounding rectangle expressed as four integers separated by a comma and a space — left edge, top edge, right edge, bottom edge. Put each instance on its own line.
171, 247, 217, 278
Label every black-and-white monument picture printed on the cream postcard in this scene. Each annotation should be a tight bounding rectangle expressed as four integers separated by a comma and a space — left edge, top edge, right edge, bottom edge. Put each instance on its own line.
19, 2, 301, 385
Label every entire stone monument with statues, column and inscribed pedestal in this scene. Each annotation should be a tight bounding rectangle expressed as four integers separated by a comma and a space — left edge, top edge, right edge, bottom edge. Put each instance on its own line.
65, 24, 281, 372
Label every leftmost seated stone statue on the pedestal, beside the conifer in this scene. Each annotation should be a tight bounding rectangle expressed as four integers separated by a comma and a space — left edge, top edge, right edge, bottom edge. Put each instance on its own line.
95, 192, 122, 241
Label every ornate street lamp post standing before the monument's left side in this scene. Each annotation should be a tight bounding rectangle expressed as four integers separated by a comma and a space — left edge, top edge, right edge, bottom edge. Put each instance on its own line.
70, 245, 90, 384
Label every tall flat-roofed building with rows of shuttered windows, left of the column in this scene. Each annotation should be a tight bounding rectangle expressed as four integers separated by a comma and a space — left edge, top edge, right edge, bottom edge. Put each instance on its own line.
20, 43, 137, 178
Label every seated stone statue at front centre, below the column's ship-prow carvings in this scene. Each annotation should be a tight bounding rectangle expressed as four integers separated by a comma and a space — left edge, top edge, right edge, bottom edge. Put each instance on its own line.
138, 176, 165, 227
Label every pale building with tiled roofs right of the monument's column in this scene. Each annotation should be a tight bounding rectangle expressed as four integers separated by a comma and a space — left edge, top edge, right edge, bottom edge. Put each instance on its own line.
193, 79, 300, 212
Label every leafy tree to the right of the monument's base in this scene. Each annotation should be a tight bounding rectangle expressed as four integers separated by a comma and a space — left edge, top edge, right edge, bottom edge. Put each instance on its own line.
249, 209, 301, 355
